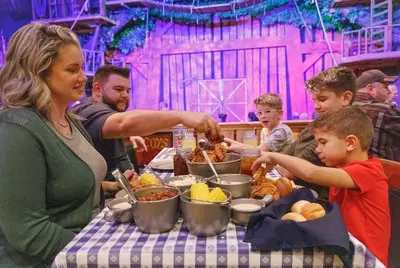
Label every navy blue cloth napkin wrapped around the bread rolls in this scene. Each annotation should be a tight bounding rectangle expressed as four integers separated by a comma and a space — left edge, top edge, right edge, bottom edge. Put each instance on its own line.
243, 188, 350, 256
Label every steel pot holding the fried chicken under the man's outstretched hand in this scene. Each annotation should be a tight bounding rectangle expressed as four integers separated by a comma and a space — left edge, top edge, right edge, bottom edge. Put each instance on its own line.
187, 153, 242, 178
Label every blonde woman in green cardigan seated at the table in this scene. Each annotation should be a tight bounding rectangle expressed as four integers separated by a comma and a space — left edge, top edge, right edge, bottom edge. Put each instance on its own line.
0, 23, 107, 268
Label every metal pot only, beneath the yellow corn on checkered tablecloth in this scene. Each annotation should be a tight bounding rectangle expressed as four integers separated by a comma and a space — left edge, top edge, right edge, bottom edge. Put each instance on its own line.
180, 189, 232, 236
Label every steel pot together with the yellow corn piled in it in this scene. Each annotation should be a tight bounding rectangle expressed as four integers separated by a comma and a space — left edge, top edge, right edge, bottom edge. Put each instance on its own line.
180, 183, 232, 237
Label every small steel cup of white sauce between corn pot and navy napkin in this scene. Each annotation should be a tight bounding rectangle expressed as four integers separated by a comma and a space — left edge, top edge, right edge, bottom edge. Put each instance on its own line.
231, 198, 265, 225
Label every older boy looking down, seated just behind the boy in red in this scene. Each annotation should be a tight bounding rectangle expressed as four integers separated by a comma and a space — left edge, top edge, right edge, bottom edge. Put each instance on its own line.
278, 67, 357, 199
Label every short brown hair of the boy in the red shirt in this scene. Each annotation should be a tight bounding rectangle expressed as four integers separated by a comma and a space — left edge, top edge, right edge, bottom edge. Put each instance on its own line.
311, 106, 374, 151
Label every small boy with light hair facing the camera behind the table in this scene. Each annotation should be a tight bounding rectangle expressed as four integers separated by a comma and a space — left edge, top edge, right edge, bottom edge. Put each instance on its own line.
225, 93, 294, 152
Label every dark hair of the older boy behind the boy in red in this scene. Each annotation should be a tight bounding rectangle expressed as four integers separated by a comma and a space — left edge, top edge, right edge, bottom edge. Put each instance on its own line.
306, 66, 357, 104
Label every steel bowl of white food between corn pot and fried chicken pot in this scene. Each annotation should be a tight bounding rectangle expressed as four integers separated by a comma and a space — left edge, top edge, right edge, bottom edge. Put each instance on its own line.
208, 174, 253, 199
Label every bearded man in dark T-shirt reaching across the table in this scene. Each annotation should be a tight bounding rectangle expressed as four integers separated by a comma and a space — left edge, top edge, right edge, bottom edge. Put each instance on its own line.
72, 66, 220, 192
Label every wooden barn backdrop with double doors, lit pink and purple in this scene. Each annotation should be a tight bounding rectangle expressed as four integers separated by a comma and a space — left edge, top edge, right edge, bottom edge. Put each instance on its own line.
127, 17, 341, 122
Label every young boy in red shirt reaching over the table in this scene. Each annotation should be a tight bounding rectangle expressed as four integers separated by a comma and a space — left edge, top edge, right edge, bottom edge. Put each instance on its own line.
253, 107, 390, 266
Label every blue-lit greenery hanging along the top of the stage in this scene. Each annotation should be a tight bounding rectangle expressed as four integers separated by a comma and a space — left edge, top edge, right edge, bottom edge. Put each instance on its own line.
94, 0, 372, 55
